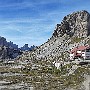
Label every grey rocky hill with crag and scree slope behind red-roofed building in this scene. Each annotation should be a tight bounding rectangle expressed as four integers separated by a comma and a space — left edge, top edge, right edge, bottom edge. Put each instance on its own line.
20, 10, 90, 59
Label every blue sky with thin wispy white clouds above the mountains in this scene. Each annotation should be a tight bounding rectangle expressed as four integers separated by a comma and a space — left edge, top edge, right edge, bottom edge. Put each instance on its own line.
0, 0, 90, 47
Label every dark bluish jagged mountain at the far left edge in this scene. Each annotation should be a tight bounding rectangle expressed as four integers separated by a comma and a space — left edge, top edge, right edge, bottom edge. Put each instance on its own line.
0, 36, 21, 59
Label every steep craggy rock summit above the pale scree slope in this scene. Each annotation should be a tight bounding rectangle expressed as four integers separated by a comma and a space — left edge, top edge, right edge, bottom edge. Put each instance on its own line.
53, 10, 90, 37
